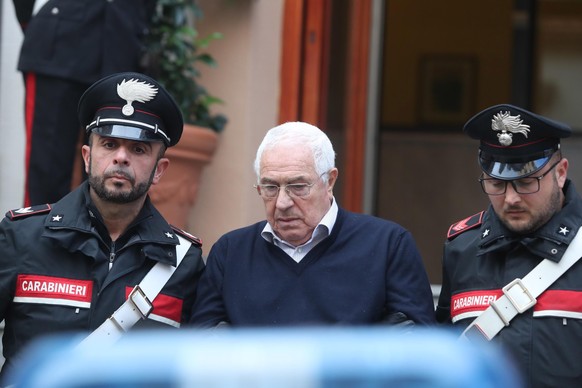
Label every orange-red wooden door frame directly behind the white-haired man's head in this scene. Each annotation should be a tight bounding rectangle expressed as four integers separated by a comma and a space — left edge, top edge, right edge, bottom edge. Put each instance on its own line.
279, 0, 372, 212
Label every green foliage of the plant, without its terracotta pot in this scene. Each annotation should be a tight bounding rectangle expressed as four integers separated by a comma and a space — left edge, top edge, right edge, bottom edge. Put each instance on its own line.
146, 0, 227, 132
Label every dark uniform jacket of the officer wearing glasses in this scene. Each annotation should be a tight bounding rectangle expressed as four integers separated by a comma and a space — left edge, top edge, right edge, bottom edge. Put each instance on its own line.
436, 180, 582, 388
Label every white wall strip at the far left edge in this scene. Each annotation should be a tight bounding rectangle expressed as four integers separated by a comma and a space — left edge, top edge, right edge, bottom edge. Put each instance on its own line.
0, 0, 25, 212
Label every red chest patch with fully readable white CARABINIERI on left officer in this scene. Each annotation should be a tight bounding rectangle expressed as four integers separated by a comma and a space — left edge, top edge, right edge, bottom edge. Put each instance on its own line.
14, 275, 93, 308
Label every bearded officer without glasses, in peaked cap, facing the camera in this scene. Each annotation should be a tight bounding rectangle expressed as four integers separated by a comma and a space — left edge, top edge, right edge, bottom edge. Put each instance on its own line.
0, 73, 204, 384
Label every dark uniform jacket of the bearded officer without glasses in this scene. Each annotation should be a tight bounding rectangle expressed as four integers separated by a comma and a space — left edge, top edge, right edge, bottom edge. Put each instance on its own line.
0, 182, 204, 378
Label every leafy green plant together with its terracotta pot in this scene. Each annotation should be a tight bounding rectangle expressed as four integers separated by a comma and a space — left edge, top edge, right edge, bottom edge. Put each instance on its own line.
146, 0, 227, 228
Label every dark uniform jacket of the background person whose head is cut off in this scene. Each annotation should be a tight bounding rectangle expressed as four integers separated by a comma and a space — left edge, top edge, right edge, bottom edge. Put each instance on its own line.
14, 0, 156, 84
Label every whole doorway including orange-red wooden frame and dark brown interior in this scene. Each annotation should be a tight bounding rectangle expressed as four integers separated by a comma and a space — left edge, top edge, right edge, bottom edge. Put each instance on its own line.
280, 0, 582, 285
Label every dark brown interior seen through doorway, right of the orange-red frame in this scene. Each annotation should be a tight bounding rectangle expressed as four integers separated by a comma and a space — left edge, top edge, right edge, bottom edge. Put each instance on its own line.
374, 0, 582, 284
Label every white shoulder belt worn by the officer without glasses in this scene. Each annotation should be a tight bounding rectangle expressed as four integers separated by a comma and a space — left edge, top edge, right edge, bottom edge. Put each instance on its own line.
79, 235, 192, 347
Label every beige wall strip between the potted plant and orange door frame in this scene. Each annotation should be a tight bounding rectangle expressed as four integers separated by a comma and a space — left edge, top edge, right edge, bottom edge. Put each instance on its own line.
190, 0, 284, 255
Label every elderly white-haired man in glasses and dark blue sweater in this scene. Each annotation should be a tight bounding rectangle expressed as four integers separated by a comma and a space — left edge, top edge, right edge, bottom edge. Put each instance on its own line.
190, 122, 434, 328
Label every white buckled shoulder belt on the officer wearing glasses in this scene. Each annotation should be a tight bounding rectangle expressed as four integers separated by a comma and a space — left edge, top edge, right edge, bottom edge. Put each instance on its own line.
460, 227, 582, 341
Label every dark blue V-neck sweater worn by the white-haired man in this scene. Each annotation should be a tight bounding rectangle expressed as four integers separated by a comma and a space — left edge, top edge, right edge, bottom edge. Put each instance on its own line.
191, 209, 434, 327
